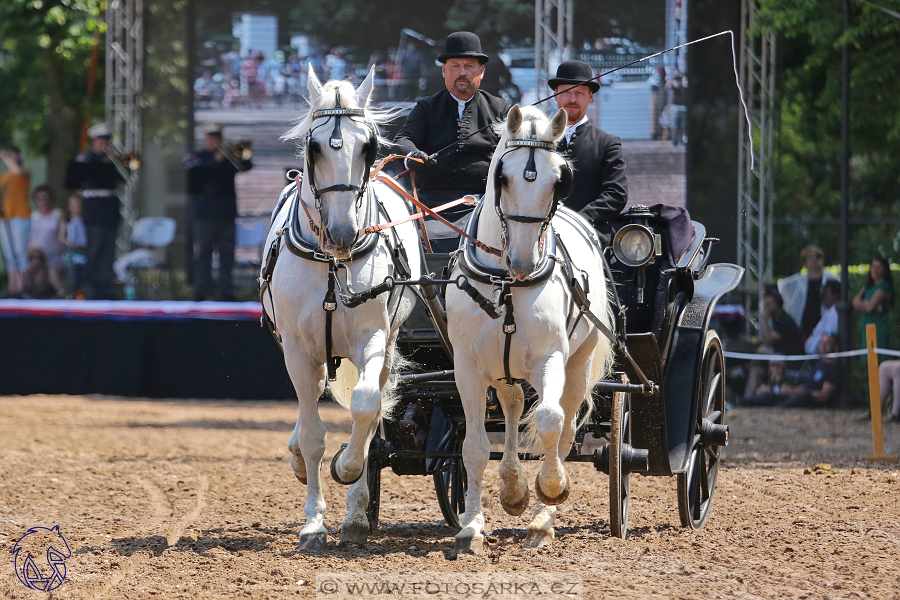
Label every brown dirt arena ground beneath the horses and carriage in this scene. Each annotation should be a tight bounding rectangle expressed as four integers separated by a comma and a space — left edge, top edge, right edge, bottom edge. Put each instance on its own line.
0, 396, 900, 599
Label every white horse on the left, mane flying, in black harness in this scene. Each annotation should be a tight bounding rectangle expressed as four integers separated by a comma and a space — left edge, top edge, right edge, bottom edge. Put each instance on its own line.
262, 68, 422, 550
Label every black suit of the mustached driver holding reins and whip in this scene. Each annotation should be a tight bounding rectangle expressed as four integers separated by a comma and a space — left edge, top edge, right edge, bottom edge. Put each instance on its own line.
394, 90, 512, 200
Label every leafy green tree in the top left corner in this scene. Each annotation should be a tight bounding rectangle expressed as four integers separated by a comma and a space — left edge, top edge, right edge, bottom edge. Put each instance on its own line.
0, 0, 105, 195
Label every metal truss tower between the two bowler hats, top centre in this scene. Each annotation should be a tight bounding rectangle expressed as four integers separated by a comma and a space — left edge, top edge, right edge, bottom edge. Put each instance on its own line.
534, 0, 575, 112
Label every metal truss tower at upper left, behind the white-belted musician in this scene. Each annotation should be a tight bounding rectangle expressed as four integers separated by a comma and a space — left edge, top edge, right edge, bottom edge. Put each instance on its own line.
106, 0, 144, 249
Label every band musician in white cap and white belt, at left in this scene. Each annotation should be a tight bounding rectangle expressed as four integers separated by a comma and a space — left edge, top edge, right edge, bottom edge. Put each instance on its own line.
66, 123, 125, 300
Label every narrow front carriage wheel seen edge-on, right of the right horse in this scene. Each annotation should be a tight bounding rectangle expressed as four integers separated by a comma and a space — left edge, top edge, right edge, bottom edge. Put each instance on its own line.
609, 392, 631, 540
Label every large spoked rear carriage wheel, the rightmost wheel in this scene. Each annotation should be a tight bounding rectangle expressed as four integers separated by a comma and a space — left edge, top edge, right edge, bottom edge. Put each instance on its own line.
677, 330, 727, 529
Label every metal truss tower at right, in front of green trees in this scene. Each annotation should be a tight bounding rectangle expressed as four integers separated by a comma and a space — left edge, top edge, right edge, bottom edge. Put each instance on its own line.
737, 0, 776, 329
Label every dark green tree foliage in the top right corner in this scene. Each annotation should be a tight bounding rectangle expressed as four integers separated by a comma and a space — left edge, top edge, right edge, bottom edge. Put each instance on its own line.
760, 0, 900, 217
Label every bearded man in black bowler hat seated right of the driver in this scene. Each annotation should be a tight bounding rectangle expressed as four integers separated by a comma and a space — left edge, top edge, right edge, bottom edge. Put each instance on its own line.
549, 60, 628, 230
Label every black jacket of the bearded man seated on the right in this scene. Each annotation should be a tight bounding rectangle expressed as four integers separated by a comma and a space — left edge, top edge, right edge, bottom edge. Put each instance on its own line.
558, 121, 628, 227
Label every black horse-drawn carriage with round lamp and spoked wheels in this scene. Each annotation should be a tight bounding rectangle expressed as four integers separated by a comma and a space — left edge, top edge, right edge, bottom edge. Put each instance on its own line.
344, 206, 743, 538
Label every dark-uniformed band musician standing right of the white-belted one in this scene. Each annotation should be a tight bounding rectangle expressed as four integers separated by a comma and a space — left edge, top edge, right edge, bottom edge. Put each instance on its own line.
184, 123, 253, 302
